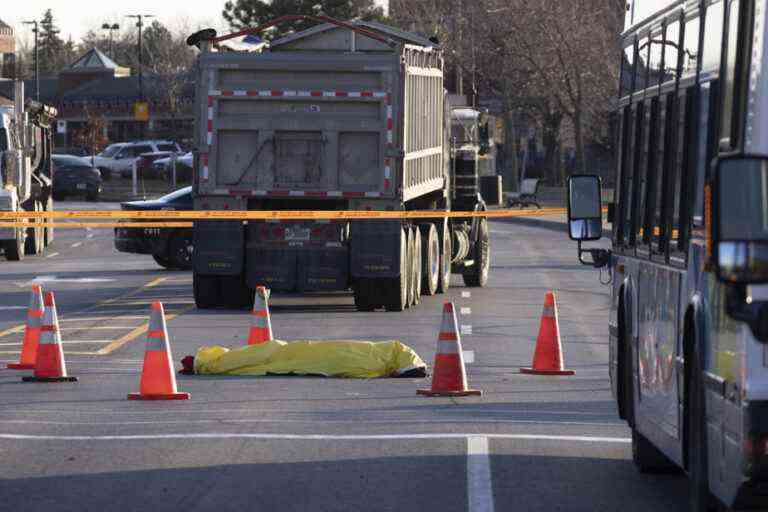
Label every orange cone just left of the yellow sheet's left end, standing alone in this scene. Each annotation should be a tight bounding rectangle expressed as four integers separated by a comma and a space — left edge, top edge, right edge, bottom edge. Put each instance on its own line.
128, 302, 189, 400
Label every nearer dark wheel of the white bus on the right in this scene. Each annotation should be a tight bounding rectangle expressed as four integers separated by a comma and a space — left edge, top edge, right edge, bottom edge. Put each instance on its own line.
686, 346, 719, 512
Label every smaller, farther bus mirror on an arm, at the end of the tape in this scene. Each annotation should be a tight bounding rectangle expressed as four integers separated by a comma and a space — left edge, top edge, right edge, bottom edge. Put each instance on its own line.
568, 174, 610, 268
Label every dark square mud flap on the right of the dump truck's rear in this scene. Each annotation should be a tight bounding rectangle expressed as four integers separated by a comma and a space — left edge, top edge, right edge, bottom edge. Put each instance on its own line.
350, 220, 402, 278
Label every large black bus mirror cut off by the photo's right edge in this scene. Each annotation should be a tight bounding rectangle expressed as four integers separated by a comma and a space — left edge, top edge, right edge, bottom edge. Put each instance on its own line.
707, 158, 768, 284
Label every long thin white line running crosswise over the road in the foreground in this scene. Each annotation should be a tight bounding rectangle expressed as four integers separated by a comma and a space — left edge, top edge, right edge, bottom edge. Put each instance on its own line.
0, 432, 632, 444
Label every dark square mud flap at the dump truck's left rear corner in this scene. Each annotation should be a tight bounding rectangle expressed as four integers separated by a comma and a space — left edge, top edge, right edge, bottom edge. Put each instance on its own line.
194, 221, 244, 276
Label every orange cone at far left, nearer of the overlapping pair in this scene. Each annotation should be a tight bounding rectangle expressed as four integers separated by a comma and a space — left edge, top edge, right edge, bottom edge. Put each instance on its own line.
21, 292, 77, 382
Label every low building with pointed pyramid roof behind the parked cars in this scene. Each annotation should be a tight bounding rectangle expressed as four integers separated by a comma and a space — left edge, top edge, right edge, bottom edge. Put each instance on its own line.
0, 48, 194, 147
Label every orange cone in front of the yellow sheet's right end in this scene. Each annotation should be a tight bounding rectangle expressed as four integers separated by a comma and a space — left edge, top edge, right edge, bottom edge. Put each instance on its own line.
416, 302, 483, 396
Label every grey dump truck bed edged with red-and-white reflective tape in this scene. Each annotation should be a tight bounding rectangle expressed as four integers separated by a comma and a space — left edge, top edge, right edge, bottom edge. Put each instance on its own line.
197, 30, 447, 201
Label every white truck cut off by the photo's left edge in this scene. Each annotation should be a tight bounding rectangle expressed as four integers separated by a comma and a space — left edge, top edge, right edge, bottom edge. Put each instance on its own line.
0, 82, 57, 261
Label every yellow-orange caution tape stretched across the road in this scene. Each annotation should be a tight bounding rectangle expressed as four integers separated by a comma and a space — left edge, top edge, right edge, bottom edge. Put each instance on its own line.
0, 208, 565, 228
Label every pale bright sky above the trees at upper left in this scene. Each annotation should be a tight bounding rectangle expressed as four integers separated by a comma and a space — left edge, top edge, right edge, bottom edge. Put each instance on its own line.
0, 0, 388, 41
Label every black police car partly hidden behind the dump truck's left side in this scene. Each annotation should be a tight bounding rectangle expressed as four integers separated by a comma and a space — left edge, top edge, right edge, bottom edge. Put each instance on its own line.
115, 187, 194, 270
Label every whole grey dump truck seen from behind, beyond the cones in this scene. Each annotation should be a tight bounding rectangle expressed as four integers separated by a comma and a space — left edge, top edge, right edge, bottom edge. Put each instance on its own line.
188, 16, 490, 311
